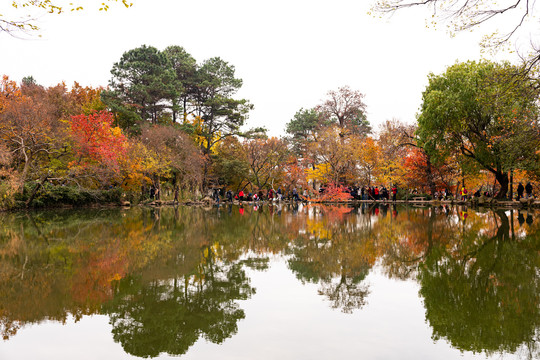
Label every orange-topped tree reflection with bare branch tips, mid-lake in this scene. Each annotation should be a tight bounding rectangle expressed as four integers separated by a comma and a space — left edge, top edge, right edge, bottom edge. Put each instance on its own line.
289, 207, 376, 313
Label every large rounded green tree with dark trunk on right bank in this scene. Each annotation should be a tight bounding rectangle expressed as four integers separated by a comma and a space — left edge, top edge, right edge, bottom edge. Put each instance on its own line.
417, 61, 540, 198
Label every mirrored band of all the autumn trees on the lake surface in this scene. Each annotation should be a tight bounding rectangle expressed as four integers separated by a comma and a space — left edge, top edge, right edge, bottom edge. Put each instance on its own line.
0, 204, 540, 358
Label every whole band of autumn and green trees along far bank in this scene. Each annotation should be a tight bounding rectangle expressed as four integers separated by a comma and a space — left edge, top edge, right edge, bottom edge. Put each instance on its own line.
0, 45, 540, 208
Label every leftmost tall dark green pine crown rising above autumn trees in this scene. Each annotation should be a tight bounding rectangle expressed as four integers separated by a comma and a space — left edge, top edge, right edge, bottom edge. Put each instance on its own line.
102, 45, 178, 128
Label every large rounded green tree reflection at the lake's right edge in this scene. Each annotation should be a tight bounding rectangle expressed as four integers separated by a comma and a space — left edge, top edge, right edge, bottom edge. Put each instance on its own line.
419, 211, 540, 353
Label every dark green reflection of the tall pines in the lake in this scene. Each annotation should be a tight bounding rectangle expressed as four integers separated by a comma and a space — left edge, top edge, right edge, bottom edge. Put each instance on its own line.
104, 247, 255, 357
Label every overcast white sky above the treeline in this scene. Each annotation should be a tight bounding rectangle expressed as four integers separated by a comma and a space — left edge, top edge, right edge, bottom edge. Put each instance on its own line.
0, 0, 520, 135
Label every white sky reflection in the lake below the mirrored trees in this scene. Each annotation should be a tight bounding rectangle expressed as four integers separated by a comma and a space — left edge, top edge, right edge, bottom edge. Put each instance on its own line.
0, 257, 524, 360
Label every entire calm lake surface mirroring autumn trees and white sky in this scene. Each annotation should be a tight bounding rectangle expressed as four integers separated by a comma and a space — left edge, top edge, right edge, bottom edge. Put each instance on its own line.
0, 205, 540, 360
